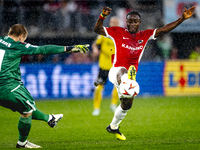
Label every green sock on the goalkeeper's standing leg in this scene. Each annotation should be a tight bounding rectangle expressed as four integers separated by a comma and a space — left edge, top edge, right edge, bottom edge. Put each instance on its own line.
18, 116, 32, 142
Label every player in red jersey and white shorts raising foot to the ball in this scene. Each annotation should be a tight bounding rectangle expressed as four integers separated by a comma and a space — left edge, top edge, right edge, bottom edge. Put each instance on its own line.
94, 6, 195, 140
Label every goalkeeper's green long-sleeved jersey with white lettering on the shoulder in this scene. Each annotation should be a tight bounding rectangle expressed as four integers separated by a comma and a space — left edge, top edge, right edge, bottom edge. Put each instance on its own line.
0, 36, 65, 90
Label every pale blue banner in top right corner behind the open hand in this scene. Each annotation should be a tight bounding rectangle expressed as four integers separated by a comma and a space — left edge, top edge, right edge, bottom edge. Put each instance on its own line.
163, 0, 200, 32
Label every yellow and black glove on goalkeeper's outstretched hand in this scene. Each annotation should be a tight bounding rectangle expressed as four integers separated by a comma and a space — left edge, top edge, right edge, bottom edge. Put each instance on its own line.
65, 44, 90, 53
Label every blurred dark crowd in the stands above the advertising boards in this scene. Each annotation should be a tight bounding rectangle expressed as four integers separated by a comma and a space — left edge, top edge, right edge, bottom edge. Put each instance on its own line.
0, 0, 200, 64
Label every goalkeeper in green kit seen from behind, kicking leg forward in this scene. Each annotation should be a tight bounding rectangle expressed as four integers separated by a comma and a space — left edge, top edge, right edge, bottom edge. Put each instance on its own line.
0, 24, 89, 148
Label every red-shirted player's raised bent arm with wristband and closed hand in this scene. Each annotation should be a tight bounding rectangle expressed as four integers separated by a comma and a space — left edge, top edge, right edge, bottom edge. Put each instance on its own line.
94, 6, 112, 36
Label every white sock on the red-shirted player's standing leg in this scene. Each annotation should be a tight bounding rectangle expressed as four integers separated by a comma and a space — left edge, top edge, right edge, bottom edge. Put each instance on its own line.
110, 105, 128, 129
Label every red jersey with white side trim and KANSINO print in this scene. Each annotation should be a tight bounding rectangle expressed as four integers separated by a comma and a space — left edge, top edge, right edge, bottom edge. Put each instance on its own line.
104, 27, 156, 70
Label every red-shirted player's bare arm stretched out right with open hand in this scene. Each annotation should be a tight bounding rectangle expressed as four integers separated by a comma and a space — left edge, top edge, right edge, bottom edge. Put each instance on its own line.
155, 6, 195, 37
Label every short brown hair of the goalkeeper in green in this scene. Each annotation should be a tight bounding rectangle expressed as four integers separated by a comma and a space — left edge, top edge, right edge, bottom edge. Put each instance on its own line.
8, 24, 28, 38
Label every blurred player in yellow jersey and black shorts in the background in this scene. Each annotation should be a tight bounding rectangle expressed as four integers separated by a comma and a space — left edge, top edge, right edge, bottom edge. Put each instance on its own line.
92, 16, 119, 116
